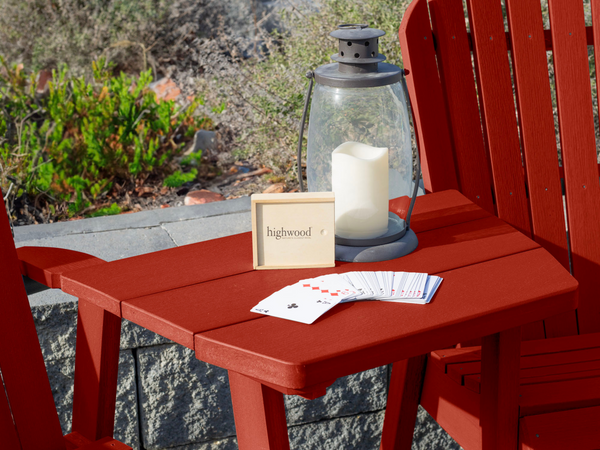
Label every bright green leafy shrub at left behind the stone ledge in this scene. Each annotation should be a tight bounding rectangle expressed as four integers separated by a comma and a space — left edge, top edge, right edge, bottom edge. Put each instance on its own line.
0, 55, 211, 214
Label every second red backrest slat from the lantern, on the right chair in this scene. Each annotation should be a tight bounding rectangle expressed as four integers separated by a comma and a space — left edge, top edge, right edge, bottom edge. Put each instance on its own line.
429, 0, 495, 214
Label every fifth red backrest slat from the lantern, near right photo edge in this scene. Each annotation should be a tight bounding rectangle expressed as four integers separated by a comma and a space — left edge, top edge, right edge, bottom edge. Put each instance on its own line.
548, 0, 600, 333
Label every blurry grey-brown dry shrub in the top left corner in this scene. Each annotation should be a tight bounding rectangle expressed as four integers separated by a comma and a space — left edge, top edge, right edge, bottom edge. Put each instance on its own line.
0, 0, 172, 74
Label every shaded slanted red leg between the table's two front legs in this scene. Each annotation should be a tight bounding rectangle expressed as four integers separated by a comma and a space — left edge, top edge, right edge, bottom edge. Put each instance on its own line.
380, 355, 427, 450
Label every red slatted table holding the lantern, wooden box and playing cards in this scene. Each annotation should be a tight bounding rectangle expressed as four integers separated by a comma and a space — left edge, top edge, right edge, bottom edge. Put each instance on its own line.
62, 191, 578, 449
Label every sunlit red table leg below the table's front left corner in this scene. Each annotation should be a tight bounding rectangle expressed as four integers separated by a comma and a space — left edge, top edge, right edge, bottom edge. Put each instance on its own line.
229, 371, 290, 450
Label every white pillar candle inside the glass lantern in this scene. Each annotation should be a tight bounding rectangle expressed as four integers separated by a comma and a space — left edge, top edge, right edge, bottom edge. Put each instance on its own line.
331, 142, 389, 239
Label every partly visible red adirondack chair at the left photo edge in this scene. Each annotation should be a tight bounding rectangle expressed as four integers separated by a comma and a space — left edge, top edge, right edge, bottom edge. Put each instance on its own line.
0, 201, 131, 450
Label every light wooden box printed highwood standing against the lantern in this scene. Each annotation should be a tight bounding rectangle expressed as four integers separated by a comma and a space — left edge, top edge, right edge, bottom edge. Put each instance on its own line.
251, 192, 335, 270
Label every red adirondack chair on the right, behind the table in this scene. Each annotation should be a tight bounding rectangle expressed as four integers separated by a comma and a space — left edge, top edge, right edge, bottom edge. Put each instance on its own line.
382, 0, 600, 450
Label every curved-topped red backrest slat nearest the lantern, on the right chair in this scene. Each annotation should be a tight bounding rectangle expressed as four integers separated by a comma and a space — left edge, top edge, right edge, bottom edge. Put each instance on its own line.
399, 2, 458, 192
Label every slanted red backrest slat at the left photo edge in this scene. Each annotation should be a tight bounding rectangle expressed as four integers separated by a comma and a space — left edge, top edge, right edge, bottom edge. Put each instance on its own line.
0, 201, 65, 450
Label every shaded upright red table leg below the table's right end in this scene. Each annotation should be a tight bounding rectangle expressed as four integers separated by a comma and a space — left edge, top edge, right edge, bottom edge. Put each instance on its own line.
480, 328, 521, 450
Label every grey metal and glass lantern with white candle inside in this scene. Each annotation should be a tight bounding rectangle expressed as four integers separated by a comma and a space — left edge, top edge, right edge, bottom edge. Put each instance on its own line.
298, 24, 420, 262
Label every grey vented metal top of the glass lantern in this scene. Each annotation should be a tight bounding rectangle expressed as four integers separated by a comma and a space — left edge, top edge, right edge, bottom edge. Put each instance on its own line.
314, 24, 402, 88
